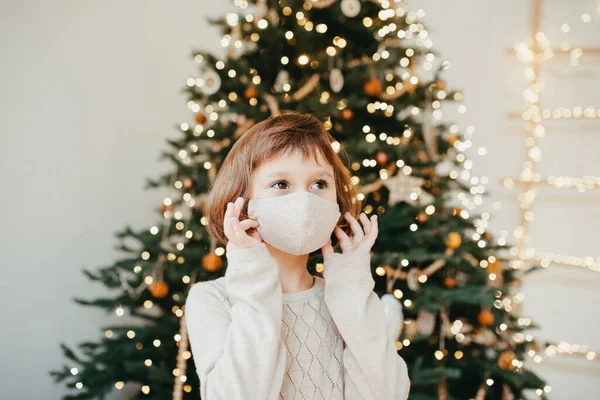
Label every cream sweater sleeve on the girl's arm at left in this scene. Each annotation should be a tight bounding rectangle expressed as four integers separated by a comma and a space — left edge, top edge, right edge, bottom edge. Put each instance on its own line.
185, 243, 286, 400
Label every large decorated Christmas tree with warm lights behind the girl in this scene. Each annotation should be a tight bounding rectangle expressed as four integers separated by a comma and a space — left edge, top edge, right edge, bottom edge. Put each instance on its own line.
51, 0, 545, 400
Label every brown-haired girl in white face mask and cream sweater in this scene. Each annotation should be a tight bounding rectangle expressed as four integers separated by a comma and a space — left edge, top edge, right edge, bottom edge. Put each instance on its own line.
185, 111, 410, 400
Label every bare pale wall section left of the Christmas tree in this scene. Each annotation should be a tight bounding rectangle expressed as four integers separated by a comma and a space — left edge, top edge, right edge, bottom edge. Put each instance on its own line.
0, 0, 233, 400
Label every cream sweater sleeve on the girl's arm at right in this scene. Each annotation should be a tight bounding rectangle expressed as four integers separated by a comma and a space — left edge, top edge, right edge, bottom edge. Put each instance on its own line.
323, 247, 410, 400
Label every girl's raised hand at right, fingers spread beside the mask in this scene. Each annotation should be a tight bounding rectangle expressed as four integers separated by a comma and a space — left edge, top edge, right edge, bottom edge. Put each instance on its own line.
321, 212, 378, 259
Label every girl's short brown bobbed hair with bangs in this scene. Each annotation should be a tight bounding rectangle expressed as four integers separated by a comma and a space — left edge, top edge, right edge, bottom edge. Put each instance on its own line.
205, 110, 361, 244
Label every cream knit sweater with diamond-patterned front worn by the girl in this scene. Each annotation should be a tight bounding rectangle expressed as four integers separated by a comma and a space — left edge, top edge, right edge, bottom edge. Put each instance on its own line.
185, 243, 410, 400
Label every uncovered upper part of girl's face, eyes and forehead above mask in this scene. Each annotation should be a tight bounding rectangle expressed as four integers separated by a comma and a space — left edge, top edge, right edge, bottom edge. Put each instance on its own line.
250, 150, 337, 202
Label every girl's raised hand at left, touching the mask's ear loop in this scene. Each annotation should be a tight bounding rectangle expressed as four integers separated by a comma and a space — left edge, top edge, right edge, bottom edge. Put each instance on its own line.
223, 197, 262, 251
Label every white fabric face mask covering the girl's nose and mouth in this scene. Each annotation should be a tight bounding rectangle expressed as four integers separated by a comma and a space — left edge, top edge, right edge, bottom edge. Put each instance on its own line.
248, 192, 341, 255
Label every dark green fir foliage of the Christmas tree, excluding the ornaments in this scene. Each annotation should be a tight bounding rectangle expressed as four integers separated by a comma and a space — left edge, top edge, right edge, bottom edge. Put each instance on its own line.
51, 0, 545, 400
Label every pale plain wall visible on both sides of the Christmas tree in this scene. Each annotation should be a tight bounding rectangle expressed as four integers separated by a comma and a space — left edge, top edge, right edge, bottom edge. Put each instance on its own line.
0, 0, 600, 399
